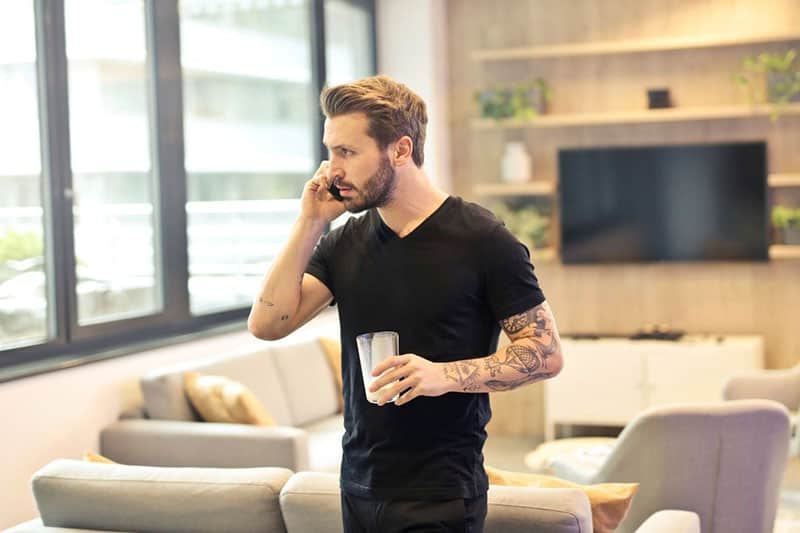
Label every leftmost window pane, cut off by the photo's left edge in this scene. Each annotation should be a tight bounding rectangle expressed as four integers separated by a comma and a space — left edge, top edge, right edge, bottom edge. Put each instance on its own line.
0, 0, 48, 347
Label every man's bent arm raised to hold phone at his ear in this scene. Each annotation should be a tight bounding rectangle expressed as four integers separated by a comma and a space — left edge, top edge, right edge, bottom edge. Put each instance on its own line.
247, 162, 344, 340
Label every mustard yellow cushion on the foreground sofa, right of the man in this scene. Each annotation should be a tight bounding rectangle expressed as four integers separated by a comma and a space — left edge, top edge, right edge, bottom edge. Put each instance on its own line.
485, 466, 639, 533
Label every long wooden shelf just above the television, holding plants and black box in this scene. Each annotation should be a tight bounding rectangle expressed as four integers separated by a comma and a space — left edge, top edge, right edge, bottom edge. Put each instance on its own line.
472, 103, 800, 130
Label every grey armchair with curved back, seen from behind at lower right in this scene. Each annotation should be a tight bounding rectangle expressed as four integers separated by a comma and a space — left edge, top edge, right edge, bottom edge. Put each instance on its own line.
549, 400, 789, 533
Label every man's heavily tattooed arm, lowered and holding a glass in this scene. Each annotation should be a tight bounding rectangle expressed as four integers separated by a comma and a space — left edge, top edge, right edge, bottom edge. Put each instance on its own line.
370, 301, 563, 405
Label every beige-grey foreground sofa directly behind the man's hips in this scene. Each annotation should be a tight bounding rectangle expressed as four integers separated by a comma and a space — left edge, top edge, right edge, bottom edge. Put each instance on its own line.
8, 459, 700, 533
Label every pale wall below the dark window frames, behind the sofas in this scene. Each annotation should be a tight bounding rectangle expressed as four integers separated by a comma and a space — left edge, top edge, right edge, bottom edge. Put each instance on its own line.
0, 310, 339, 530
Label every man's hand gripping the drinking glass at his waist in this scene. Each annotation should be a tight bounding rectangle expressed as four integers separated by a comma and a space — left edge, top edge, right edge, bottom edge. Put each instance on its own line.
369, 354, 453, 405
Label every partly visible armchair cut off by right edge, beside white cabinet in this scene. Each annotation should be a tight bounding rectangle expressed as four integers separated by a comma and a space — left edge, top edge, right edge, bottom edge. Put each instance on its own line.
722, 365, 800, 411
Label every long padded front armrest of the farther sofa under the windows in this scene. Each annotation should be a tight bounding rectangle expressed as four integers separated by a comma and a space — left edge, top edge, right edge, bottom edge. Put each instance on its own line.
100, 420, 309, 470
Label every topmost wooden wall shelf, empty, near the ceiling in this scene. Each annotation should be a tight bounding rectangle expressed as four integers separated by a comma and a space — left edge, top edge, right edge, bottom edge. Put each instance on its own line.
470, 33, 800, 61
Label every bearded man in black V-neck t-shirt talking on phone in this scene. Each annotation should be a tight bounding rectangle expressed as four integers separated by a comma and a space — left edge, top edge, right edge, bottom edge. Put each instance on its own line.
248, 76, 562, 533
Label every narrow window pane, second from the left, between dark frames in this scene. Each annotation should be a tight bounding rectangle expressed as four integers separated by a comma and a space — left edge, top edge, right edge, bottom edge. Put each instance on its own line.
65, 0, 161, 325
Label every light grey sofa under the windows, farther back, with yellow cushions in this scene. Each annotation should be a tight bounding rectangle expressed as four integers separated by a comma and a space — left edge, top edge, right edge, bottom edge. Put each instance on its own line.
100, 340, 344, 472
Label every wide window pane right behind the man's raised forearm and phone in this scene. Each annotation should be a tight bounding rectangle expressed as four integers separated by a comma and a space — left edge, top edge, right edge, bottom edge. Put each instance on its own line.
180, 0, 316, 313
